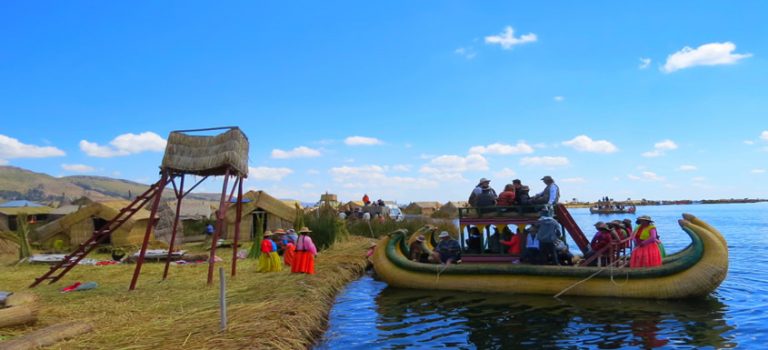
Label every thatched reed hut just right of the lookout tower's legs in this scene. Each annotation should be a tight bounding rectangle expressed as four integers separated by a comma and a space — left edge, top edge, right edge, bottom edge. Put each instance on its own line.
222, 191, 296, 241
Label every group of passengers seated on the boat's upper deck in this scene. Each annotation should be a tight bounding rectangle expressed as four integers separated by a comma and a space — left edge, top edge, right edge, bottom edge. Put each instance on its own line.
468, 176, 560, 212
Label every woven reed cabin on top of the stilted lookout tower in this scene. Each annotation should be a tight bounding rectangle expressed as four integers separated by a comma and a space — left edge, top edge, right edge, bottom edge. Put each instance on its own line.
162, 128, 249, 176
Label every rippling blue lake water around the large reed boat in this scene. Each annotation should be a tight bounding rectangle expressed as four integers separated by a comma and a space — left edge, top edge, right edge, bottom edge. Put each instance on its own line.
317, 203, 768, 349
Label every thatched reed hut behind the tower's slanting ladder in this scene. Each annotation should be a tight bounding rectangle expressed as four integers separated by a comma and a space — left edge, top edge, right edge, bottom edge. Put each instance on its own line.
32, 201, 154, 247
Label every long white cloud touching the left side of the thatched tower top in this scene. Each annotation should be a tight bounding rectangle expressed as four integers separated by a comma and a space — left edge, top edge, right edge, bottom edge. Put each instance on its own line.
80, 131, 167, 158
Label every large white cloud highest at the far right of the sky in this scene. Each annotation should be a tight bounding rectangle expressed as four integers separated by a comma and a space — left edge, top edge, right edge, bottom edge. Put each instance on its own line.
661, 41, 752, 73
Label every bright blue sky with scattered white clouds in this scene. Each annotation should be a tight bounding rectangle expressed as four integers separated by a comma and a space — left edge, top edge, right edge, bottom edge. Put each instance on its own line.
0, 1, 768, 203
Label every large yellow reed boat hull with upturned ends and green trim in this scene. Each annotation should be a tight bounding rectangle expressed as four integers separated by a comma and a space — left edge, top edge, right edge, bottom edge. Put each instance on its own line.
372, 214, 728, 299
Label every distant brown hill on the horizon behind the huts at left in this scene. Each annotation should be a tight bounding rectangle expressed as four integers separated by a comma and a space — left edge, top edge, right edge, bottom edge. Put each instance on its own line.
0, 166, 217, 202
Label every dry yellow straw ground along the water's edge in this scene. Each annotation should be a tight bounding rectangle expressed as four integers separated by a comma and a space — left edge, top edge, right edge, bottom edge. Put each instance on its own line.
0, 236, 371, 349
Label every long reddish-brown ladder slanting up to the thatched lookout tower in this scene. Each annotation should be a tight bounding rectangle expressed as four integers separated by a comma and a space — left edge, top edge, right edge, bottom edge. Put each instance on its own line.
29, 180, 163, 288
